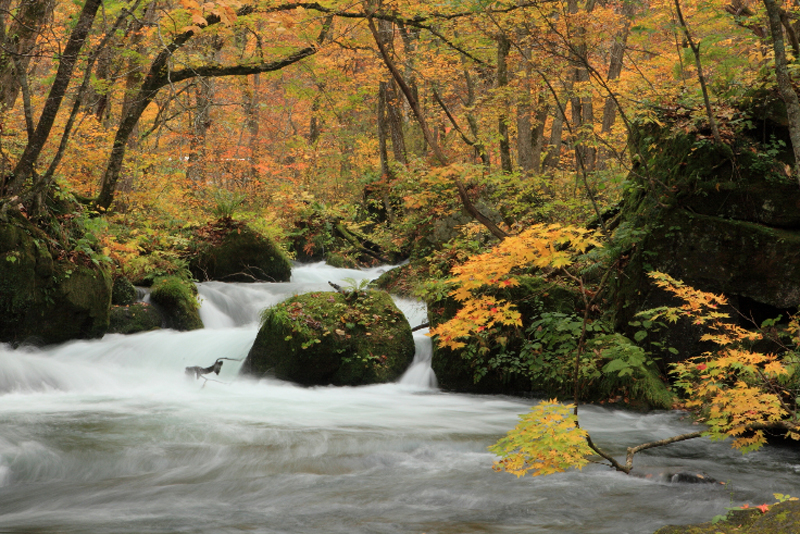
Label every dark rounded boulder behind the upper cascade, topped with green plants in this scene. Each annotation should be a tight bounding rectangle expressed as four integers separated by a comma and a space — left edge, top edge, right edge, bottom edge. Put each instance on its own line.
189, 219, 292, 282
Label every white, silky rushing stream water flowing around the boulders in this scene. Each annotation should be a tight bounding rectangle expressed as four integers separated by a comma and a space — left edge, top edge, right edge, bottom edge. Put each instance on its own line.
0, 264, 800, 534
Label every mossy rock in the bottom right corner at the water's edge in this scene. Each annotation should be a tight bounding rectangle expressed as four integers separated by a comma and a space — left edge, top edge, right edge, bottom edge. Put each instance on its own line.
655, 501, 800, 534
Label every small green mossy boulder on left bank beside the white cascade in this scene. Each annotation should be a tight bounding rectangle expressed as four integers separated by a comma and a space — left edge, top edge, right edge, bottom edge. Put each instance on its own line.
150, 276, 203, 330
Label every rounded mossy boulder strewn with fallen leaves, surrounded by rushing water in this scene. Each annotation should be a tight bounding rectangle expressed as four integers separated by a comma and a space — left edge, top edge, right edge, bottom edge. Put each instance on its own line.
243, 291, 414, 386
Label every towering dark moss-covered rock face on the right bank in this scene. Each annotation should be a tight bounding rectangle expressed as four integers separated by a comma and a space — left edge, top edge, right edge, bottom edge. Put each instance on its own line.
611, 104, 800, 363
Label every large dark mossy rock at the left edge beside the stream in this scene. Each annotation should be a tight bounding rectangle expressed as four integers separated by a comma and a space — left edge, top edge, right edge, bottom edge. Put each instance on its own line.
0, 211, 111, 343
